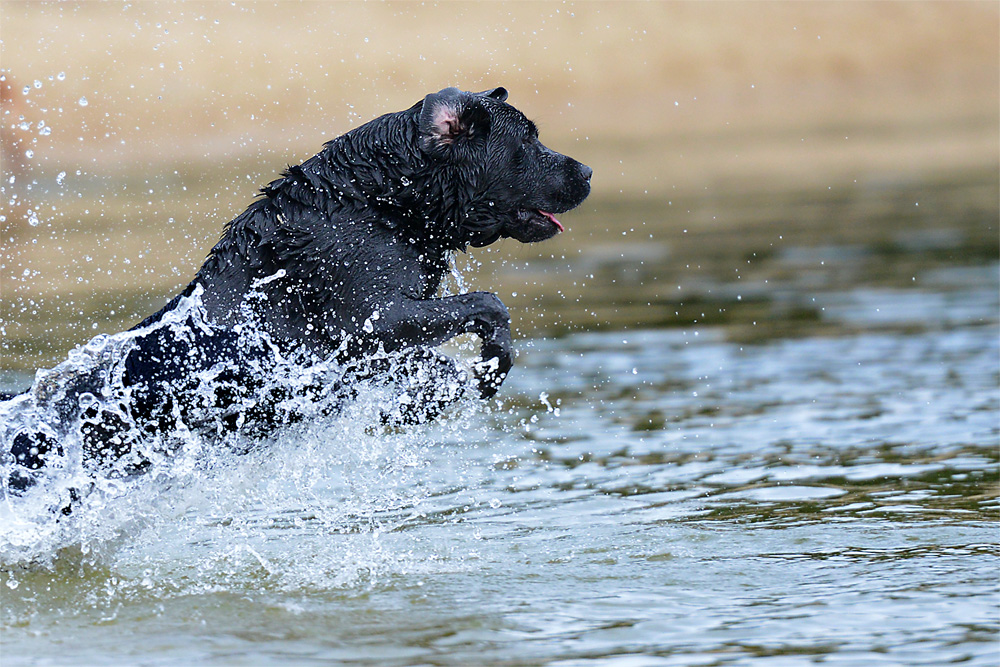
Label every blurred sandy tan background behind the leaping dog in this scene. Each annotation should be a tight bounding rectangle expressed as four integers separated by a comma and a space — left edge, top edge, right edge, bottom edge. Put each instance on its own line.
0, 0, 1000, 370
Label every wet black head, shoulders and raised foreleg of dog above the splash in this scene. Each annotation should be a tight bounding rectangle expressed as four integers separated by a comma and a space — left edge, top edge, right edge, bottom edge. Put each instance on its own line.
195, 89, 590, 368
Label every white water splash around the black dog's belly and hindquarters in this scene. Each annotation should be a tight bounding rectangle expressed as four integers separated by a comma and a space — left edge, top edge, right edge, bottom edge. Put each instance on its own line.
0, 289, 478, 572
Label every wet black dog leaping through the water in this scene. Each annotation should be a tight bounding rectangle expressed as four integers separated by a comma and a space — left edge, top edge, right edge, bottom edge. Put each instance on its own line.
0, 88, 591, 490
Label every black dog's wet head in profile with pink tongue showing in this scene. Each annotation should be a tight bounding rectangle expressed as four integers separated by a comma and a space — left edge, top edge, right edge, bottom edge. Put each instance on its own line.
419, 88, 592, 247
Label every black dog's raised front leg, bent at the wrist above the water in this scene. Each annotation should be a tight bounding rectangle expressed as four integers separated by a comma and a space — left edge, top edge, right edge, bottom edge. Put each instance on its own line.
371, 292, 513, 398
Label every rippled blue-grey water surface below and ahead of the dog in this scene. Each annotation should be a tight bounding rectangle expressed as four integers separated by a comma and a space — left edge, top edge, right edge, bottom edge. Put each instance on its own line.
0, 175, 1000, 667
